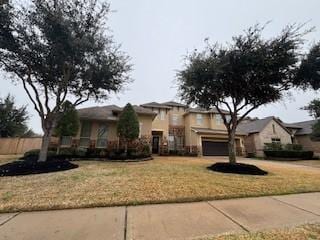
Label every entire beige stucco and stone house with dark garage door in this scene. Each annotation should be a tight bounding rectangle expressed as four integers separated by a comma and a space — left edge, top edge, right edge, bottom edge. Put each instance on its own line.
61, 102, 246, 156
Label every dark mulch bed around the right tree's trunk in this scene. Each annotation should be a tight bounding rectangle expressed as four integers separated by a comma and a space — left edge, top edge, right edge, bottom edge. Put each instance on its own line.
208, 162, 268, 175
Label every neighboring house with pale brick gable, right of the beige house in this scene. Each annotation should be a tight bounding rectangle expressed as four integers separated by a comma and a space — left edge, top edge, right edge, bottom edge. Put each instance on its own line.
237, 116, 296, 157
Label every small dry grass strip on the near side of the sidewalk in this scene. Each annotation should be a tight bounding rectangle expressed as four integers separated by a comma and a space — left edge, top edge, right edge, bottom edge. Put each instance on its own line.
211, 224, 320, 240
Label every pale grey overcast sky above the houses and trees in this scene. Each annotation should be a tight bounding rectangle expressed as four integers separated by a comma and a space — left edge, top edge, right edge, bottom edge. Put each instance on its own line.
0, 0, 320, 133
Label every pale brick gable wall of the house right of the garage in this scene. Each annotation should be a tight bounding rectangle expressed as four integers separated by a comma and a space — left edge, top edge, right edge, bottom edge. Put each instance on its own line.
254, 120, 292, 157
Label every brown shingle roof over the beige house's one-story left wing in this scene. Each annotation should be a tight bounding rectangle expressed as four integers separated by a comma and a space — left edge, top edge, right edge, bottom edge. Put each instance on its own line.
77, 105, 156, 120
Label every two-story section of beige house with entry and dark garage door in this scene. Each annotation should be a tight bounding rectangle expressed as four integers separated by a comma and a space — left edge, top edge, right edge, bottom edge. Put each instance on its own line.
141, 102, 245, 156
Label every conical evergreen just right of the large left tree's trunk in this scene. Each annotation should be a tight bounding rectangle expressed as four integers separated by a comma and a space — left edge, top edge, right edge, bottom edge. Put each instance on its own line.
55, 101, 80, 137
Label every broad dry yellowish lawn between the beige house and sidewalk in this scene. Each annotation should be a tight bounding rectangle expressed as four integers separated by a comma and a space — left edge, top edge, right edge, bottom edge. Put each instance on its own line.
0, 157, 320, 212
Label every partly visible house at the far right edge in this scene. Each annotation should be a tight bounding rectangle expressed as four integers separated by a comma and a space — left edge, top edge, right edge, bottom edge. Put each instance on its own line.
284, 120, 320, 156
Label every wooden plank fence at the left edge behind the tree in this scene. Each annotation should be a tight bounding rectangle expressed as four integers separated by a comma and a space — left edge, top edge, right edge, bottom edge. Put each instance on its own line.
0, 137, 42, 155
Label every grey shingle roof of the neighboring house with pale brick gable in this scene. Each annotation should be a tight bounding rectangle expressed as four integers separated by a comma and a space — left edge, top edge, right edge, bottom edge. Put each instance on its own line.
237, 116, 288, 134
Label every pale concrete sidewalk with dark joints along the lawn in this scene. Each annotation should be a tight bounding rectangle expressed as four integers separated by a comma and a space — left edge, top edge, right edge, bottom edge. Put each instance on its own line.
0, 193, 320, 240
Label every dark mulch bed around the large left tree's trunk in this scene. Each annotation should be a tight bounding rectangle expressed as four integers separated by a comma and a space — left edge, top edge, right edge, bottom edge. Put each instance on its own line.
0, 160, 78, 177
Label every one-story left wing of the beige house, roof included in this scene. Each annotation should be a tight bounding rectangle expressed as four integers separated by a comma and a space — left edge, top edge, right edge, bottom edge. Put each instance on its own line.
61, 105, 156, 148
